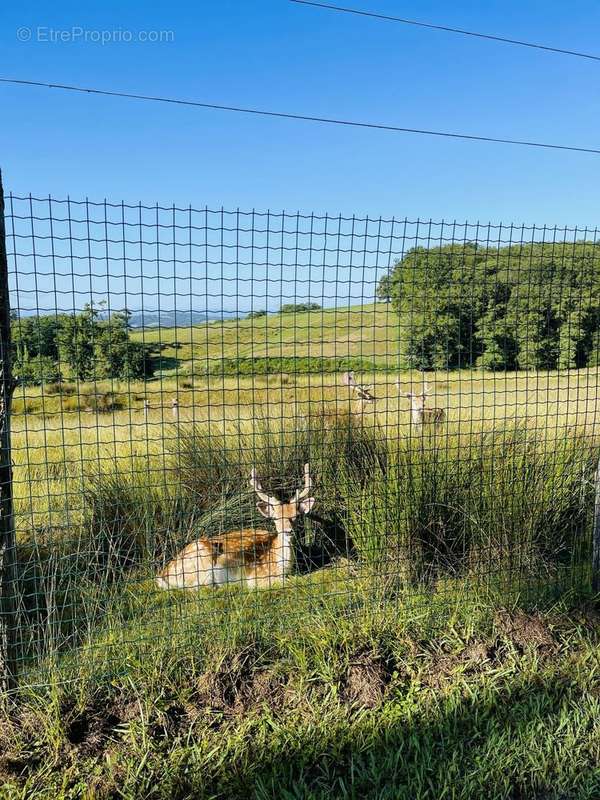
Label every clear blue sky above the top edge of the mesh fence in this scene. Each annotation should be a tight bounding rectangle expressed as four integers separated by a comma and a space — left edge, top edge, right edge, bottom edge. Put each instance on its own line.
0, 0, 600, 225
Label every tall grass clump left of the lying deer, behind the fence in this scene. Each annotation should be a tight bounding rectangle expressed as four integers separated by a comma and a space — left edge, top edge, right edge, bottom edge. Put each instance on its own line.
11, 460, 194, 660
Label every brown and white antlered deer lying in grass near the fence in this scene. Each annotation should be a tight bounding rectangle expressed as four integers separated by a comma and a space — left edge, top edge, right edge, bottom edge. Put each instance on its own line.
156, 464, 315, 589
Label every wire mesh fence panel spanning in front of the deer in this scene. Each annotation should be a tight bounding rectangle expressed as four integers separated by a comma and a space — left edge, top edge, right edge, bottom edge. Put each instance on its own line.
3, 194, 600, 684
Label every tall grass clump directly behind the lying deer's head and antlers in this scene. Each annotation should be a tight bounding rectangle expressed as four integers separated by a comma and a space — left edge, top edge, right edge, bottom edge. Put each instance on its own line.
170, 412, 386, 555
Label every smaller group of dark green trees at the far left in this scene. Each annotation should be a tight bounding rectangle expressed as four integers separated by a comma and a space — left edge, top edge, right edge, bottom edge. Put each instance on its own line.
11, 305, 152, 385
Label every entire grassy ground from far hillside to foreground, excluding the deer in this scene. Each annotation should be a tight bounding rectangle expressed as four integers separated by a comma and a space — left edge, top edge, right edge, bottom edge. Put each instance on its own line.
0, 305, 600, 800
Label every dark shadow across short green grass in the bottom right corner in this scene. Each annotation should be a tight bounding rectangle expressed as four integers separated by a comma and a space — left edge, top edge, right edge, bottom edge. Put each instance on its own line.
186, 675, 600, 800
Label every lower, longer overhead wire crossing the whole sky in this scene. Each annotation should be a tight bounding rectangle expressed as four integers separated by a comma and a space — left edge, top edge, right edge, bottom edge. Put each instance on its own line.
0, 77, 600, 155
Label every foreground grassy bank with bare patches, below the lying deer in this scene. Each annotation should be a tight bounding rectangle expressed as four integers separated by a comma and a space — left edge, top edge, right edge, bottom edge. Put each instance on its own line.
0, 574, 600, 800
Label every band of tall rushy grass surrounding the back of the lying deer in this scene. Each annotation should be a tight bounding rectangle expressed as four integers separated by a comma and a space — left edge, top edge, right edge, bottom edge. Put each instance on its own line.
8, 414, 598, 680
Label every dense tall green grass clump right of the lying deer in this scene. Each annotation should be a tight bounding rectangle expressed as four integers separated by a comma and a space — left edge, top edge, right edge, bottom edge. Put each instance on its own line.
344, 428, 598, 584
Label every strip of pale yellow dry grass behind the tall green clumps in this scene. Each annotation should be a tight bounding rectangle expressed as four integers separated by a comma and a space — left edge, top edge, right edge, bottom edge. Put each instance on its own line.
12, 369, 599, 530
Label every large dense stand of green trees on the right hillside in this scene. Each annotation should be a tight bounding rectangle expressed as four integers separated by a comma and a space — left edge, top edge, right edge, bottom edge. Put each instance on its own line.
377, 241, 600, 370
